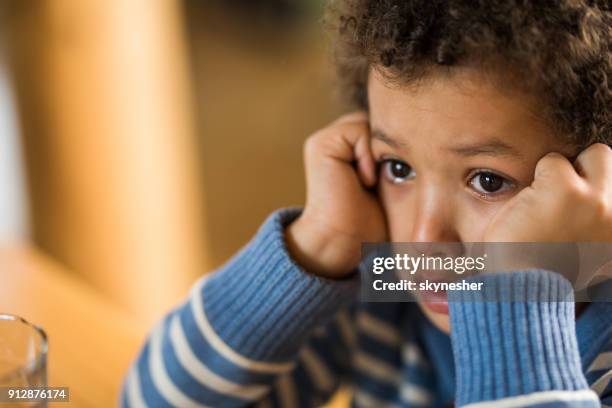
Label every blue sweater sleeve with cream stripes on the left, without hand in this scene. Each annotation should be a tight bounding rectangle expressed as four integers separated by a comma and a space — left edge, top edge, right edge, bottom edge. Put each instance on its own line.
121, 210, 359, 407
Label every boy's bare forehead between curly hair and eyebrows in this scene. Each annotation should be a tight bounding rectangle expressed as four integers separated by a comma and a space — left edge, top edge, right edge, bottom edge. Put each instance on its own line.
368, 70, 558, 155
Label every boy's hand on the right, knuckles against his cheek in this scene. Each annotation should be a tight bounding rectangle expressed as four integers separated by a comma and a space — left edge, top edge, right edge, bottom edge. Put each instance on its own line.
485, 143, 612, 242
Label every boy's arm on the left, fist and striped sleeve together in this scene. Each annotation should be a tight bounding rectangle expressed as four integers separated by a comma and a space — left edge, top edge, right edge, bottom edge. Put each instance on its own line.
123, 112, 386, 407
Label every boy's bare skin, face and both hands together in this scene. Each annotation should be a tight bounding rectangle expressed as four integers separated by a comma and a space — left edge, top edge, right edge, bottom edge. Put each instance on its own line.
287, 70, 612, 333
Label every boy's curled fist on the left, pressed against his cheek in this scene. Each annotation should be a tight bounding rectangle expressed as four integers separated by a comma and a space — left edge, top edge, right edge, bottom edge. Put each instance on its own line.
287, 112, 387, 278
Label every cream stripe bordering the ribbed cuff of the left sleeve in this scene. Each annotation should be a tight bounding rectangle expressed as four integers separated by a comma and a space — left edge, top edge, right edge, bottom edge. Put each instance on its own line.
189, 278, 295, 374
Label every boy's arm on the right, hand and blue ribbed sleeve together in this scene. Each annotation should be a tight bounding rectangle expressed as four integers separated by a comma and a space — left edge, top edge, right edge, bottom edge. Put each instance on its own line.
460, 143, 612, 407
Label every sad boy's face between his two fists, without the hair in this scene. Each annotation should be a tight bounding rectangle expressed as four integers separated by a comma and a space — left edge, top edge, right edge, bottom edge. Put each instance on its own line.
368, 67, 573, 332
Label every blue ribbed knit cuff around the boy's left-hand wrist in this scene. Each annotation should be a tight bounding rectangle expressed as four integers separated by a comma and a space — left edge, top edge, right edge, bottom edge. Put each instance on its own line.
203, 209, 359, 362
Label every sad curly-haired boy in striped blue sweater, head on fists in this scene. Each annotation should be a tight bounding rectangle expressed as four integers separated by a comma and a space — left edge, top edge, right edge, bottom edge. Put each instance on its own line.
122, 0, 612, 407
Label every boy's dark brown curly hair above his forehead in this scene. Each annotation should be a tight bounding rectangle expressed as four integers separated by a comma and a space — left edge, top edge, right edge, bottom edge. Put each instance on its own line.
325, 0, 612, 147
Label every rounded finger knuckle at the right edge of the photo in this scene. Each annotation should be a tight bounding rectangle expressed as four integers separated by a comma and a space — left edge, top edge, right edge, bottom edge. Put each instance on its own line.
574, 143, 612, 187
